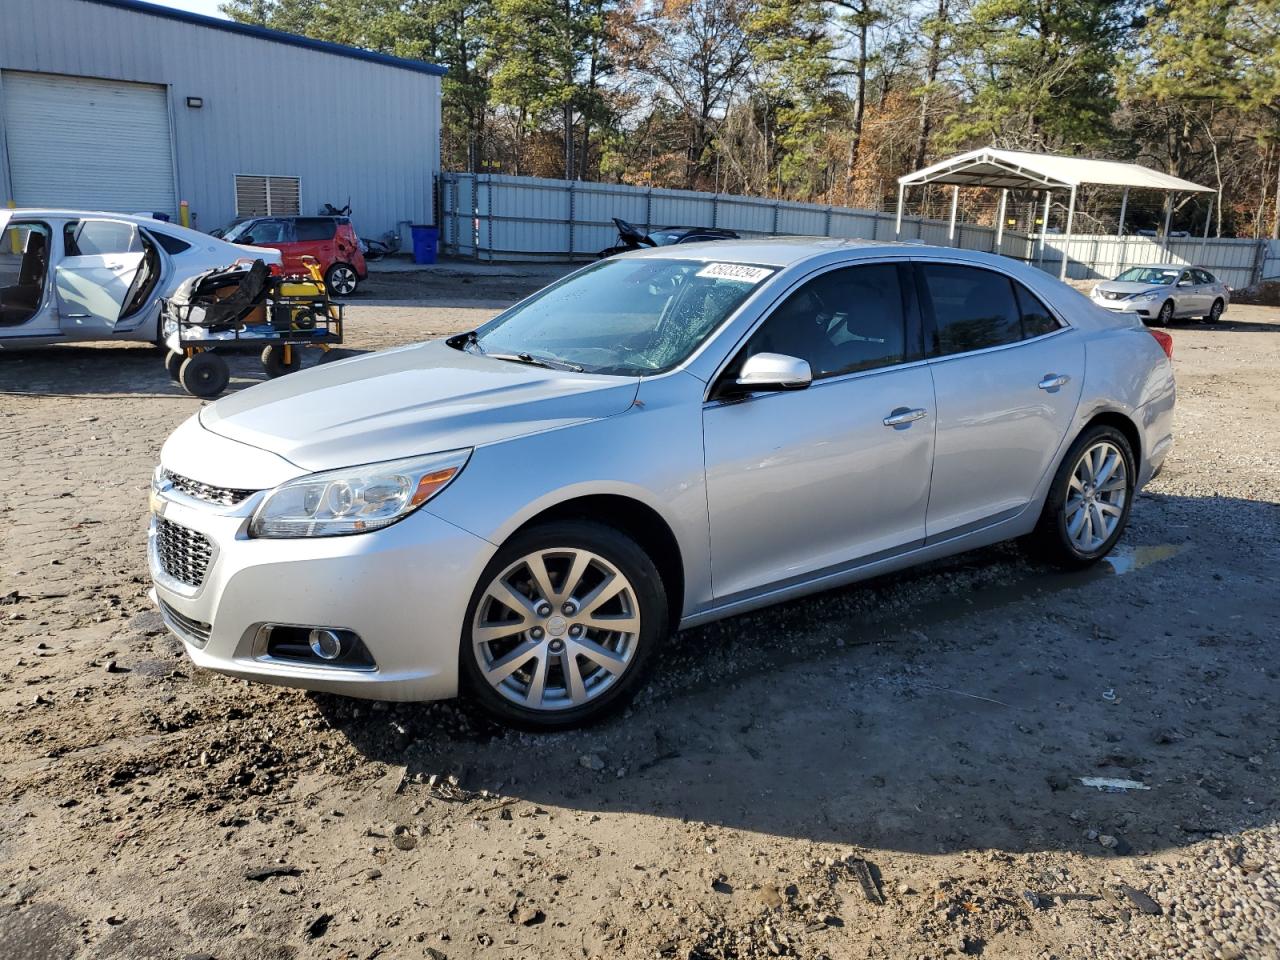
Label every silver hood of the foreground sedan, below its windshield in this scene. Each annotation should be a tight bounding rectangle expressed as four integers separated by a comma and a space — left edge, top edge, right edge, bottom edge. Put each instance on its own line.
200, 340, 640, 470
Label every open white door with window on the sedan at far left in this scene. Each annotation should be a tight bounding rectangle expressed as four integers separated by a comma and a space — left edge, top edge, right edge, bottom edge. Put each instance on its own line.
54, 218, 146, 332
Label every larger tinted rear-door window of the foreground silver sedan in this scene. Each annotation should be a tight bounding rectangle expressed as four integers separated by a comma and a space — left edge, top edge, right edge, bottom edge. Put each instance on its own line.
922, 264, 1023, 356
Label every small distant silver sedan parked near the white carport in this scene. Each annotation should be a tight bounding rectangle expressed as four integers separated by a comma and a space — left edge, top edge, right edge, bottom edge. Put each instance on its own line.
1091, 264, 1231, 326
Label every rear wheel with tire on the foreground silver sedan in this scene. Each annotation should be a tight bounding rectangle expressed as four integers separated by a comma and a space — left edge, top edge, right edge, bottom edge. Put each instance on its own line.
1032, 425, 1138, 570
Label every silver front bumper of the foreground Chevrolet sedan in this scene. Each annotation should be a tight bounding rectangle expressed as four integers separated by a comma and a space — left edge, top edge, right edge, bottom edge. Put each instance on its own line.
147, 478, 495, 700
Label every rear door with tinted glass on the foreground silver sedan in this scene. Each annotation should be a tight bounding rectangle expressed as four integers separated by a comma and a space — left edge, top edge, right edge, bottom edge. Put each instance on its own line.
918, 262, 1084, 540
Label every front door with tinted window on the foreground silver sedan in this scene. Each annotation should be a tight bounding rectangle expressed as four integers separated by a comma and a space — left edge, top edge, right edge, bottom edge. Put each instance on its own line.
703, 264, 934, 599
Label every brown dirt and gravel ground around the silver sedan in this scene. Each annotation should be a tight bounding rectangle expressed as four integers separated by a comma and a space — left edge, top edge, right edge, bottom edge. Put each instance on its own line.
0, 275, 1280, 960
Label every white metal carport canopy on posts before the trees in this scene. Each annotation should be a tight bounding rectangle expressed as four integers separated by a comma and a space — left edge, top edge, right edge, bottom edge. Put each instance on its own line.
896, 147, 1215, 278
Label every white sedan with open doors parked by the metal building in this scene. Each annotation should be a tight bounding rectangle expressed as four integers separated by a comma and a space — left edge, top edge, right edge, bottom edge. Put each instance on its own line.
0, 210, 282, 349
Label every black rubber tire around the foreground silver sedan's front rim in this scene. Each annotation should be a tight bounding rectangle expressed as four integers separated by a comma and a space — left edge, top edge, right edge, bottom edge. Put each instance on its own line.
458, 521, 669, 731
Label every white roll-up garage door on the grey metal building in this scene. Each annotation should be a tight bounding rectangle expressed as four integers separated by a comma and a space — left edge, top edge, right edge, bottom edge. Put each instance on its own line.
0, 70, 178, 215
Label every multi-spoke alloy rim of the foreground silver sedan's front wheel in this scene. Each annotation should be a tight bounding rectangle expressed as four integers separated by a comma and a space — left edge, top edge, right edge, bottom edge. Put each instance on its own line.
471, 548, 640, 710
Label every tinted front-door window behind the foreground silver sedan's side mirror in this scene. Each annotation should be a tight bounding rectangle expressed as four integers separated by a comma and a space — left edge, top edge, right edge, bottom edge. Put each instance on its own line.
740, 264, 908, 380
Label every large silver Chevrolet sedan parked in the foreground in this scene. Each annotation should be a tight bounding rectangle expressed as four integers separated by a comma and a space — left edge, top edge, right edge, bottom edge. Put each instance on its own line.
150, 239, 1175, 727
